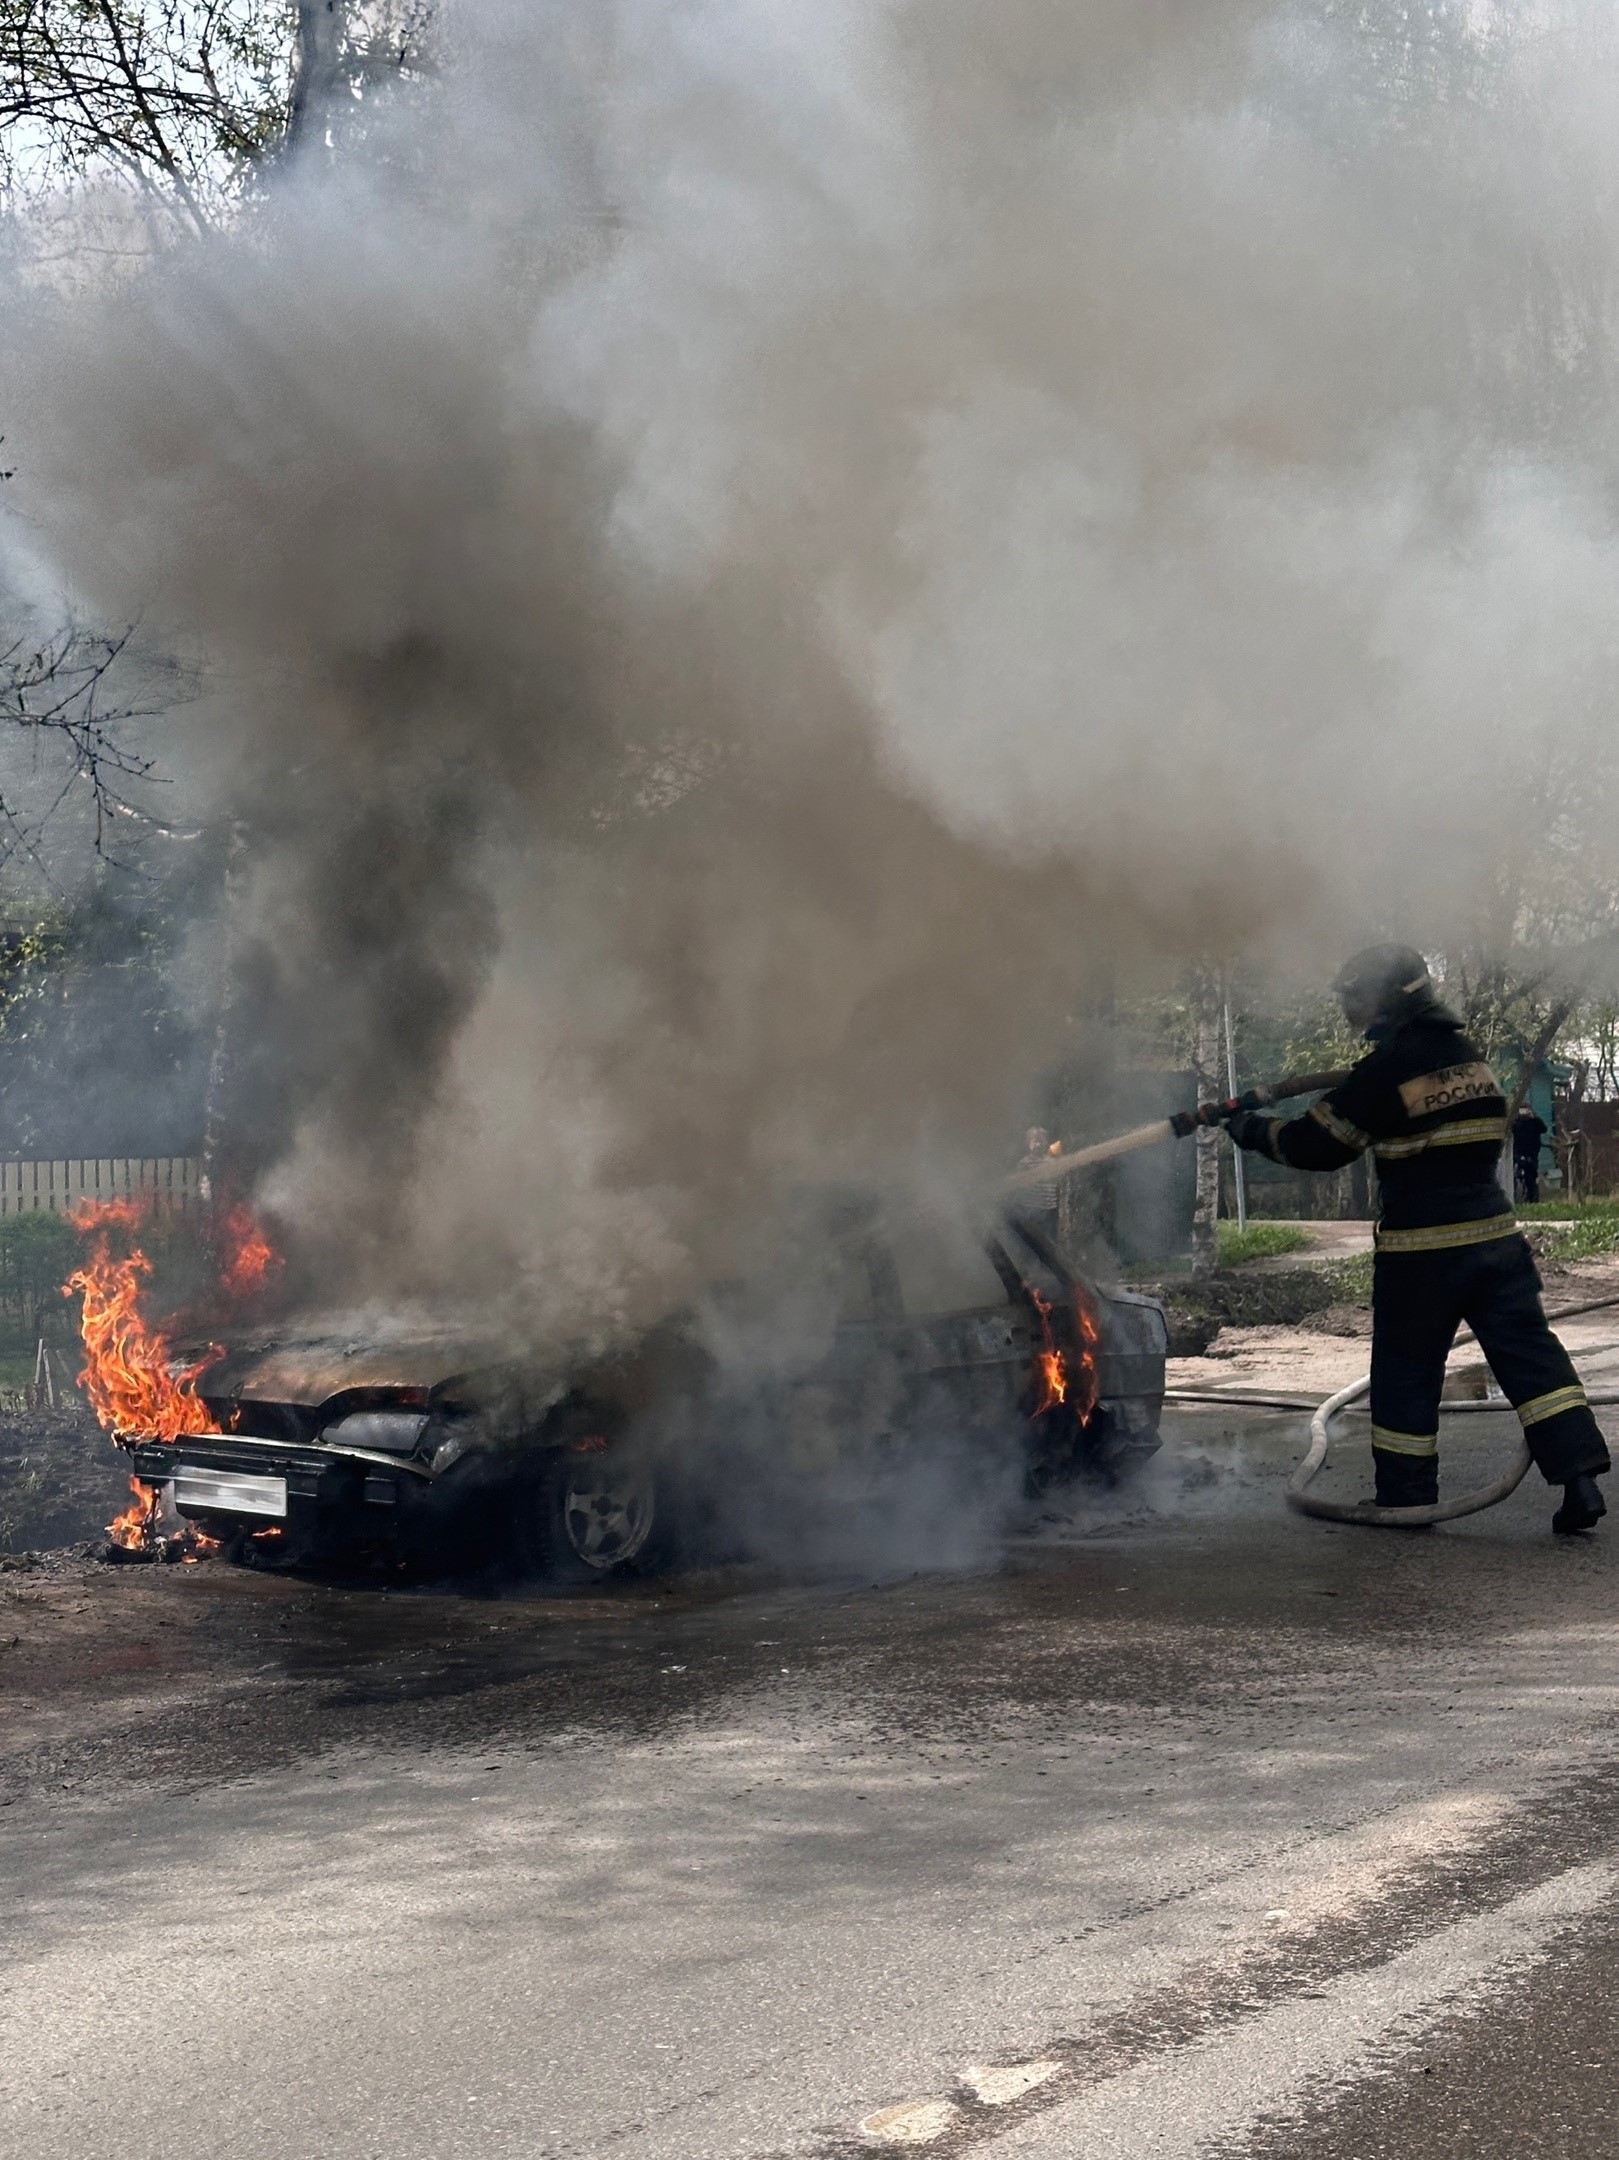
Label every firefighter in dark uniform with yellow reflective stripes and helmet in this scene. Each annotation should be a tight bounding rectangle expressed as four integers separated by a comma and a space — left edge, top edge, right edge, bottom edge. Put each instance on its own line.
1226, 946, 1608, 1536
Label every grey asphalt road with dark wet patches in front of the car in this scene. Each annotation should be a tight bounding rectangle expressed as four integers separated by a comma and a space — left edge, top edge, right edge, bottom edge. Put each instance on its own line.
0, 1417, 1619, 2160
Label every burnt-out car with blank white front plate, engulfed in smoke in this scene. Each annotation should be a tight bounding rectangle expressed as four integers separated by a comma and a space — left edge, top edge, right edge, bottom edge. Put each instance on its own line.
104, 1197, 1168, 1581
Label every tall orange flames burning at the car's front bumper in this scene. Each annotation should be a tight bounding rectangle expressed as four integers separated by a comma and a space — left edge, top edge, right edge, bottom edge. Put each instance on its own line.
63, 1201, 222, 1551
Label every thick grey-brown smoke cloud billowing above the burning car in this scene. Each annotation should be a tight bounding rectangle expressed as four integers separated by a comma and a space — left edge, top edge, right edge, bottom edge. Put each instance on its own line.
6, 0, 1619, 1326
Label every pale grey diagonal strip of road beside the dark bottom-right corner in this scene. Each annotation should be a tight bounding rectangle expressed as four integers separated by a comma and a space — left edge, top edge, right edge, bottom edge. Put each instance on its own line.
995, 1862, 1619, 2160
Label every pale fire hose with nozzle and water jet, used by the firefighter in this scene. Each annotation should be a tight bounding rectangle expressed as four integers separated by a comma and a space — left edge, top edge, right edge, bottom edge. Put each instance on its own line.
1006, 1071, 1619, 1529
